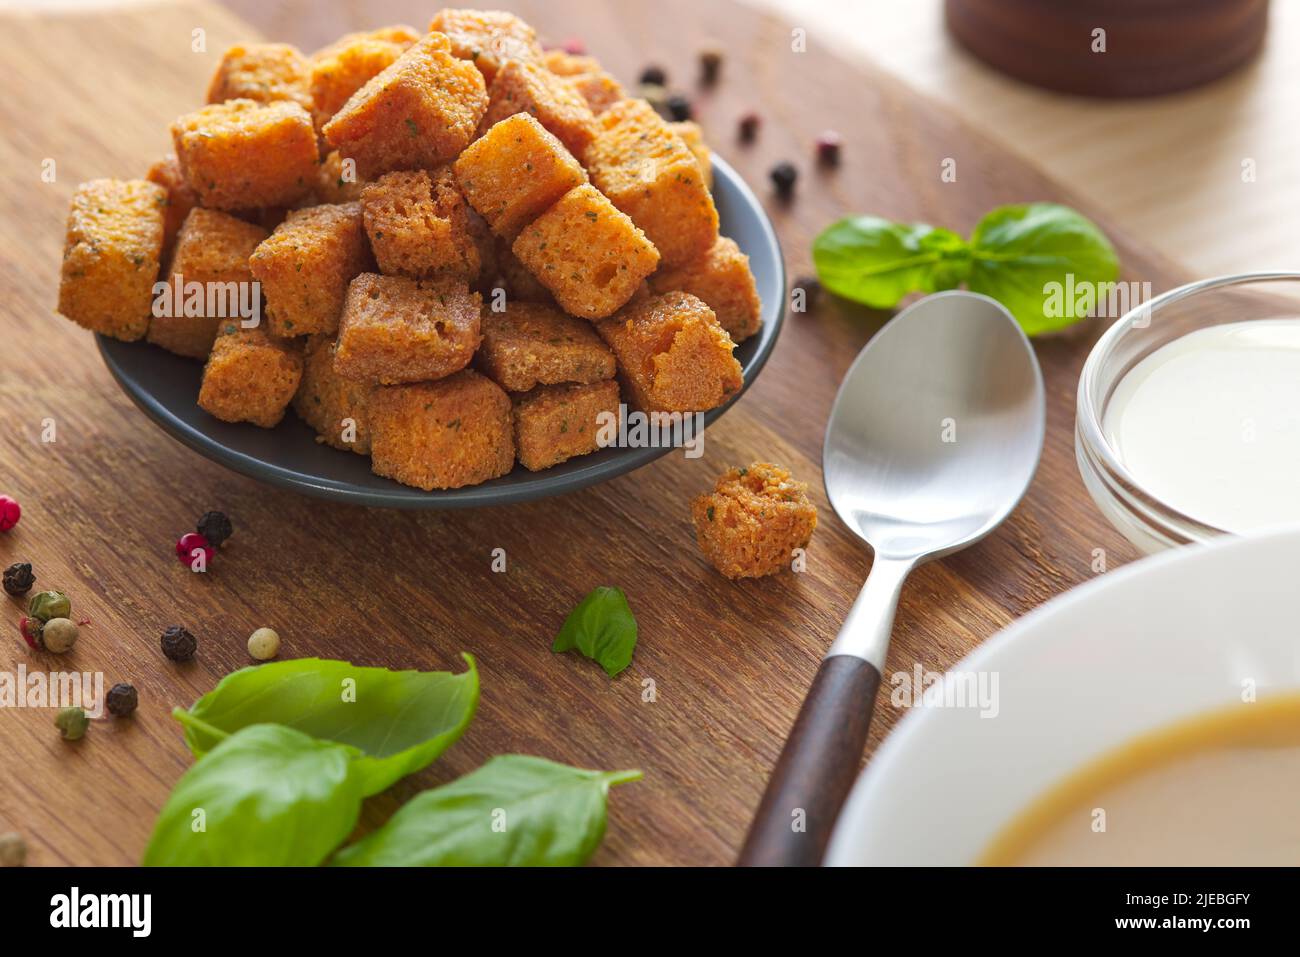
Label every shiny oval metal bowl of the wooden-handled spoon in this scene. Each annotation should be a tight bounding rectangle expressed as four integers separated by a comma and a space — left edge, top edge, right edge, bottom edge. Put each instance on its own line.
822, 291, 1045, 560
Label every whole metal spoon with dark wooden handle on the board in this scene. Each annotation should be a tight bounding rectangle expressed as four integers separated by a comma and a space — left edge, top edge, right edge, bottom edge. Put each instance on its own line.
740, 291, 1045, 865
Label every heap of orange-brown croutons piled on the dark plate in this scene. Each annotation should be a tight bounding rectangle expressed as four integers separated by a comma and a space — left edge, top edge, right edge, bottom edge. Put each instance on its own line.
59, 9, 761, 490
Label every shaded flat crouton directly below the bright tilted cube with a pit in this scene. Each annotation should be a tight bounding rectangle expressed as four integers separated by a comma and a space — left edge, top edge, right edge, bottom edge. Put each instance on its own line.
476, 302, 615, 393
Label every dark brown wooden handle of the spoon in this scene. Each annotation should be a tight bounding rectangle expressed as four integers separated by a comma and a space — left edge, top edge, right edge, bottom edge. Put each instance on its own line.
737, 654, 880, 867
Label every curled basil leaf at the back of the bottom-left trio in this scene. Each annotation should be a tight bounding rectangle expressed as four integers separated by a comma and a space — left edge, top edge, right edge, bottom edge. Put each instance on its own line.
176, 654, 478, 796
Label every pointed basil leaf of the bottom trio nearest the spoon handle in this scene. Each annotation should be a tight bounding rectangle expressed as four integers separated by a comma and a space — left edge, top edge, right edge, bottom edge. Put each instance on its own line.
334, 754, 641, 867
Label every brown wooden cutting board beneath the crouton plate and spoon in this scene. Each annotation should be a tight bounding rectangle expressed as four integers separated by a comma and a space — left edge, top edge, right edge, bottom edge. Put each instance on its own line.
0, 0, 1182, 865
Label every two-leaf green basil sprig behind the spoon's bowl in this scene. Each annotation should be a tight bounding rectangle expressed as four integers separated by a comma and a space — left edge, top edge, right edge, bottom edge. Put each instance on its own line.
813, 203, 1119, 335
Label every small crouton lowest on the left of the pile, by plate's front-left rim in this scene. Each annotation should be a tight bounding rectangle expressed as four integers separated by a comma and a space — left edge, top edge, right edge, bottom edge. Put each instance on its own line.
199, 320, 303, 429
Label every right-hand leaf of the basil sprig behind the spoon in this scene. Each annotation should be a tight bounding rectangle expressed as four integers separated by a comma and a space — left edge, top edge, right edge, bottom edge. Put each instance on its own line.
966, 203, 1119, 335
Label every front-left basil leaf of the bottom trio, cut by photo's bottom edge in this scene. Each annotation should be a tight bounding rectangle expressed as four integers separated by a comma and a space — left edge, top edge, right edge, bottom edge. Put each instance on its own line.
144, 724, 361, 867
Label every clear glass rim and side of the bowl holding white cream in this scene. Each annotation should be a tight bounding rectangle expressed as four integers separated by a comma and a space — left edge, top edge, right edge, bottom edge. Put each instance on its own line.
1074, 272, 1300, 554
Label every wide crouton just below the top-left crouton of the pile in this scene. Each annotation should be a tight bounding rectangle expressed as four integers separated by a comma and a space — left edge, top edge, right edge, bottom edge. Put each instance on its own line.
172, 100, 320, 209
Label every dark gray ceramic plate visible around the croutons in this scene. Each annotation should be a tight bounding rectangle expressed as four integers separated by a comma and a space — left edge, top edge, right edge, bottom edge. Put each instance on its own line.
96, 159, 785, 508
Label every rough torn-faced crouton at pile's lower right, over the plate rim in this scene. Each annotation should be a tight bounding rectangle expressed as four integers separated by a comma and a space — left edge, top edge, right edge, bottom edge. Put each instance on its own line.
595, 293, 744, 412
